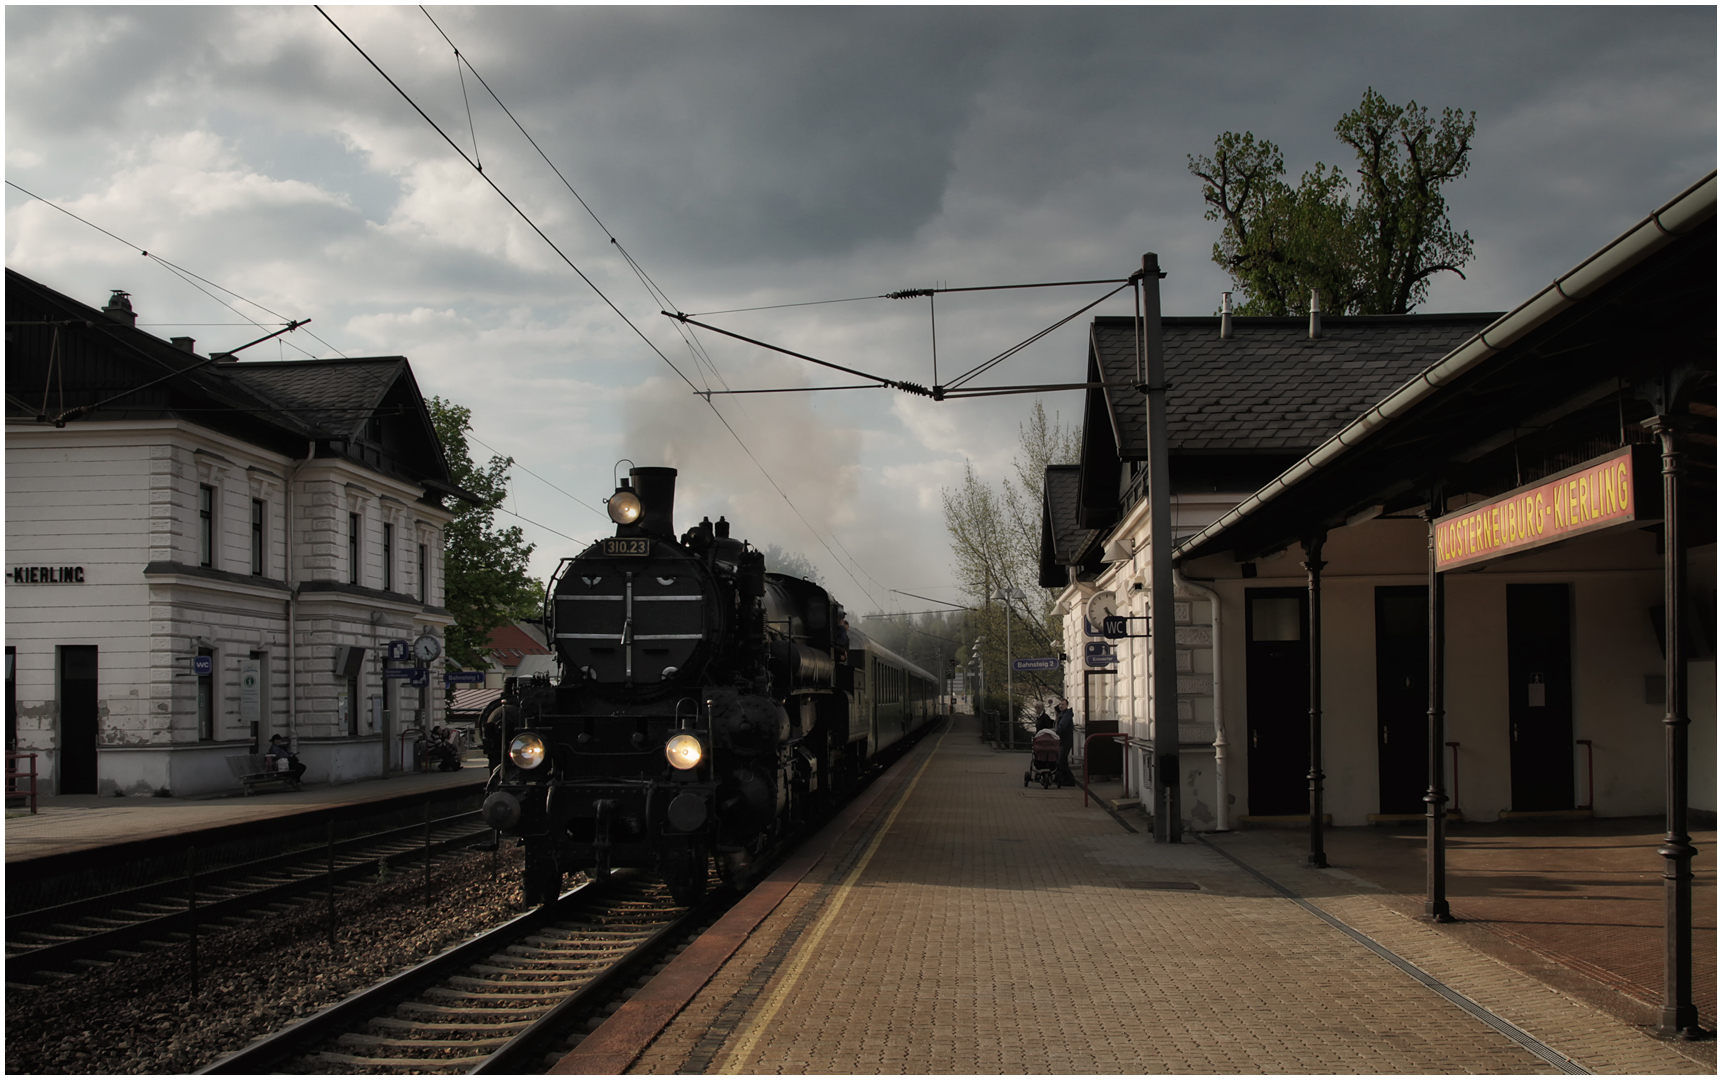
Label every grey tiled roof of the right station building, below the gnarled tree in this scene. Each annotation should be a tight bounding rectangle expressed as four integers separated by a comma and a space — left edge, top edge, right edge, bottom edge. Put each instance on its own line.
1090, 313, 1498, 460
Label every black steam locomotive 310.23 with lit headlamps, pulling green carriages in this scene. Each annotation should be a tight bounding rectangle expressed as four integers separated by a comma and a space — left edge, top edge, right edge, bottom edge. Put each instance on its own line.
484, 469, 938, 904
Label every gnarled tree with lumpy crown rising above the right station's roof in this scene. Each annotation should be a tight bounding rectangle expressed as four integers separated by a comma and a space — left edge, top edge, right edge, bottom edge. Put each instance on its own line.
1188, 88, 1476, 315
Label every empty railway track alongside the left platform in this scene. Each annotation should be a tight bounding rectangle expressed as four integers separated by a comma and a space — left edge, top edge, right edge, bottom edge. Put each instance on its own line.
5, 811, 491, 987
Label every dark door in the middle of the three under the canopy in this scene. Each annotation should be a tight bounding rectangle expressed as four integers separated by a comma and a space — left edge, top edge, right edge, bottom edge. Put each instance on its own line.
1376, 586, 1429, 813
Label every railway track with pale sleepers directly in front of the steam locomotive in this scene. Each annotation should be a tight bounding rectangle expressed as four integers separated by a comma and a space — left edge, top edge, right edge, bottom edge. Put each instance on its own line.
203, 872, 722, 1075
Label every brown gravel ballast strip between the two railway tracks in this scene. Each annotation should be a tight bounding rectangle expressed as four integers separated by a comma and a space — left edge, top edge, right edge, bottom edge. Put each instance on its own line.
5, 846, 522, 1073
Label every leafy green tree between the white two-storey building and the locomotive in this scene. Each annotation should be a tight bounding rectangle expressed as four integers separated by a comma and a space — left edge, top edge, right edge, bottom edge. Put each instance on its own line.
427, 398, 544, 668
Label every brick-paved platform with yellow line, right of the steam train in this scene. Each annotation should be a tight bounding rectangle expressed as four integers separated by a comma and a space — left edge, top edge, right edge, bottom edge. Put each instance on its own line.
601, 717, 1713, 1073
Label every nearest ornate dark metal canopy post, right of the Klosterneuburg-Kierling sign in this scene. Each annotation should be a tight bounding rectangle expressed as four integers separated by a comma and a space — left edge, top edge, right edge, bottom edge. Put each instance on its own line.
1650, 416, 1705, 1039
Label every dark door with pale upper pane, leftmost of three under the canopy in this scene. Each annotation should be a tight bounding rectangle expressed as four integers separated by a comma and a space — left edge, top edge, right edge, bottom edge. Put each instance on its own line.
1243, 589, 1309, 815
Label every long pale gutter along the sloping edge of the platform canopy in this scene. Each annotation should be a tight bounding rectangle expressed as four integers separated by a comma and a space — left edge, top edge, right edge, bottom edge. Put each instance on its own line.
1173, 169, 1717, 560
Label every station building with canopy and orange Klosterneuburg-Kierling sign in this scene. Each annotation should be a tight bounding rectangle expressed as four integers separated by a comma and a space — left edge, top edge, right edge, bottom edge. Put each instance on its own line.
1040, 174, 1715, 830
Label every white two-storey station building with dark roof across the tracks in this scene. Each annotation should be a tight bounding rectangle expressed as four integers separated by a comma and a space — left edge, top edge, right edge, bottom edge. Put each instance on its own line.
5, 270, 475, 794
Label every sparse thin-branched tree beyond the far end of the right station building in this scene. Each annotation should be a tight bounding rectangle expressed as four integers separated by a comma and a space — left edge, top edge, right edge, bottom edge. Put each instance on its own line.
944, 400, 1080, 708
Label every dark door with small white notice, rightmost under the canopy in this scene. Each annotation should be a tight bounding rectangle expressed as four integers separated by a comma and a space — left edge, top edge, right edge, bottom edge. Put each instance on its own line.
1507, 584, 1572, 810
